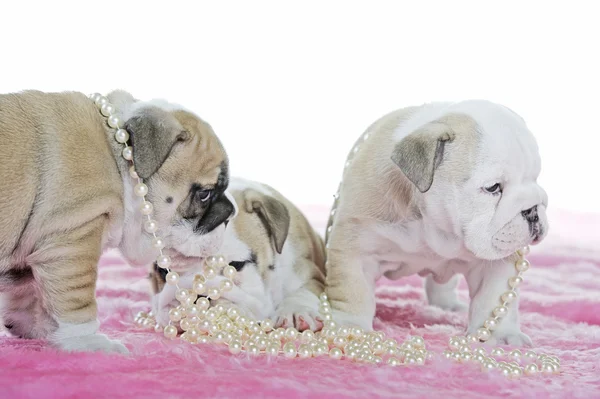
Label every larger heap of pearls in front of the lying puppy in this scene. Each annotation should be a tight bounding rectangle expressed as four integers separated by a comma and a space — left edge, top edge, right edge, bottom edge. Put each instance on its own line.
135, 276, 432, 366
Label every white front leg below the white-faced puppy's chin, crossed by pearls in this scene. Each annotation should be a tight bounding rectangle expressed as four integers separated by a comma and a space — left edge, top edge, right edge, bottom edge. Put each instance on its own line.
465, 261, 531, 346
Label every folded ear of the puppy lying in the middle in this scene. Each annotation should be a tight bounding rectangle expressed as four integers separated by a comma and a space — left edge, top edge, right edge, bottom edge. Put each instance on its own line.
244, 189, 290, 253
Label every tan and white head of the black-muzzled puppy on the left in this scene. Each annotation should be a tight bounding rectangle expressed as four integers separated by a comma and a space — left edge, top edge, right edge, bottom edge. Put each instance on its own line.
113, 94, 236, 266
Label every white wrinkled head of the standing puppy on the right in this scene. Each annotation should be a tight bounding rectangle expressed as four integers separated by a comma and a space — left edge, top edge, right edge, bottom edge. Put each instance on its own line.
394, 101, 548, 260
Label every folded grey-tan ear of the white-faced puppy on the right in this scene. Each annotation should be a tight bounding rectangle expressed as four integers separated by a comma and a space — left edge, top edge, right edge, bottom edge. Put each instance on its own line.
391, 122, 455, 193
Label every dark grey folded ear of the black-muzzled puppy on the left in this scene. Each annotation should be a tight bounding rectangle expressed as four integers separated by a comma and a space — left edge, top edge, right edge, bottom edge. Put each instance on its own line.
125, 107, 189, 179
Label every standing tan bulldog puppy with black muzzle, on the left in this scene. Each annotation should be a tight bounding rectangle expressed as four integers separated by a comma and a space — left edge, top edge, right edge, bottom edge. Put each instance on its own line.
0, 91, 234, 352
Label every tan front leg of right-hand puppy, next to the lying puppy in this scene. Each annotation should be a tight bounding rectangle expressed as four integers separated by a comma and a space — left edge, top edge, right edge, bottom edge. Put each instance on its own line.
325, 226, 376, 331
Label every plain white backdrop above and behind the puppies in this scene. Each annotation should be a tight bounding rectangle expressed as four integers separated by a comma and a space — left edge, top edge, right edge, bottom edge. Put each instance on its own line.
0, 0, 600, 211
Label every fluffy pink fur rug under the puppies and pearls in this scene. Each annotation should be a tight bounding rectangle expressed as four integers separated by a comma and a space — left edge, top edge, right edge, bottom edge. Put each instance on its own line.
0, 207, 600, 399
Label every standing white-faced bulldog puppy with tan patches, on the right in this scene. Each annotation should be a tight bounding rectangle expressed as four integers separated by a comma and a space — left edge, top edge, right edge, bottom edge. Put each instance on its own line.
326, 101, 548, 345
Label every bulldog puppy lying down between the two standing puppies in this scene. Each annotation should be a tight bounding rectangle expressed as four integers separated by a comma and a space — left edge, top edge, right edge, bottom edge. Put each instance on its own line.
150, 178, 325, 331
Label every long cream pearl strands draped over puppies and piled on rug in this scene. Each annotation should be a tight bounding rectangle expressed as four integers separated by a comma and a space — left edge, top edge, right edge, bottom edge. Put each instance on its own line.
90, 93, 560, 377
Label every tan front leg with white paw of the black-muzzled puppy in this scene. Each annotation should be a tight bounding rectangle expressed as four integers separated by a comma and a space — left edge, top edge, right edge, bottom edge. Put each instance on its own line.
27, 216, 127, 353
